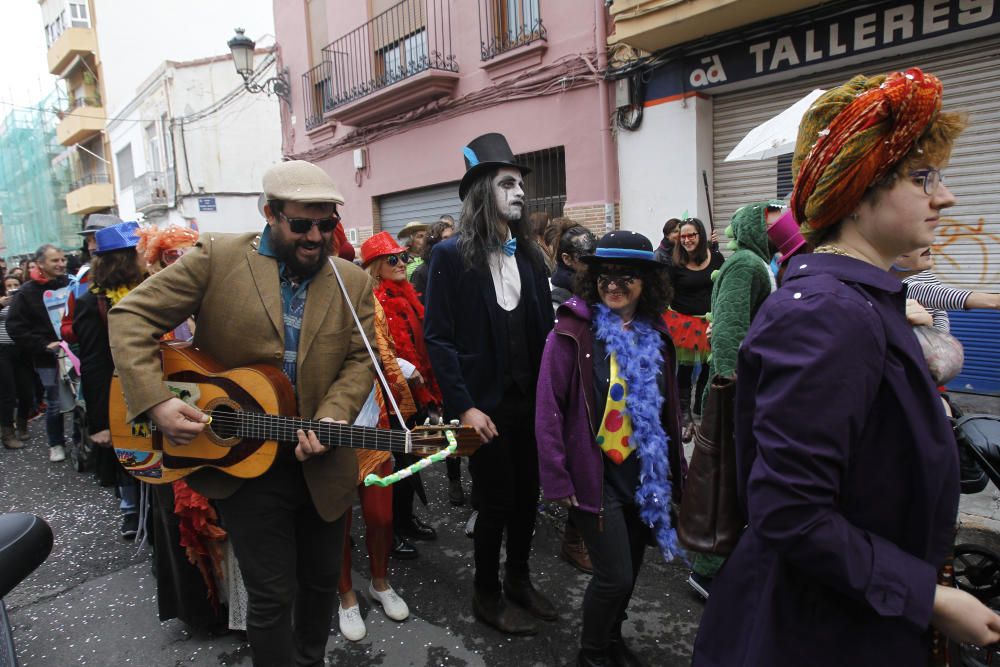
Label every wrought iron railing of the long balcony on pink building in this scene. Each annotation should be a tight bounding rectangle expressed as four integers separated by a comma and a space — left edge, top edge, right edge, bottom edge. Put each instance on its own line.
323, 0, 458, 110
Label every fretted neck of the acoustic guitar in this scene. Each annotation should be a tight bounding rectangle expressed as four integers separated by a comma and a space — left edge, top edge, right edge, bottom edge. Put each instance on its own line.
203, 411, 411, 453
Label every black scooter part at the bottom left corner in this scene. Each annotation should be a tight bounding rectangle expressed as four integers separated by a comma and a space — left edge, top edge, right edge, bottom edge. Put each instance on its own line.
0, 514, 52, 667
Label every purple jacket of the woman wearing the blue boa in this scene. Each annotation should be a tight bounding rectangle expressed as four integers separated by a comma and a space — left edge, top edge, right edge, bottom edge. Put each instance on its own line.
535, 297, 686, 514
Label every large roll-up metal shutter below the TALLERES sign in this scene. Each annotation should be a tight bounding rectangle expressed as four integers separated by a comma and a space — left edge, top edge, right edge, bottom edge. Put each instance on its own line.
712, 37, 1000, 393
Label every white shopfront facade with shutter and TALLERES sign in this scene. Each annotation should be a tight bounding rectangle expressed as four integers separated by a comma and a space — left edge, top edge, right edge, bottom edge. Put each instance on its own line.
609, 0, 1000, 392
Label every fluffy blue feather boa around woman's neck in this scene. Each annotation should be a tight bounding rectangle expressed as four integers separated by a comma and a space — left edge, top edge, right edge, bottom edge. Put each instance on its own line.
594, 303, 681, 561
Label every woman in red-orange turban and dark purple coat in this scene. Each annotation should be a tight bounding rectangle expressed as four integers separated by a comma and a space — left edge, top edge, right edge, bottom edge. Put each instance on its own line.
693, 68, 1000, 667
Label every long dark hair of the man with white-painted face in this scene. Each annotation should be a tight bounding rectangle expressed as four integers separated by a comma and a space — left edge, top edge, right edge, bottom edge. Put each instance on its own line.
458, 171, 545, 272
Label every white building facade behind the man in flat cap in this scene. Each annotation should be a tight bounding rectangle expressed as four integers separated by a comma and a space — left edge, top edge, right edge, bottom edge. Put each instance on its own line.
107, 50, 281, 232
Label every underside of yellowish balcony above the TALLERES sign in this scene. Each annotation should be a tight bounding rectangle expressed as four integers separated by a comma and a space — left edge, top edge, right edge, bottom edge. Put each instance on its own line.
608, 0, 825, 52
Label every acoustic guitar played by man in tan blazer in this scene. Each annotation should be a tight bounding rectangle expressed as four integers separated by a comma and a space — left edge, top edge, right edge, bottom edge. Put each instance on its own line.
108, 343, 481, 484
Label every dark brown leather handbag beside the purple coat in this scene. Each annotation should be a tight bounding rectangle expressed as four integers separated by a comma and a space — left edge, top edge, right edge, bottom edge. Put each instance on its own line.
677, 376, 746, 555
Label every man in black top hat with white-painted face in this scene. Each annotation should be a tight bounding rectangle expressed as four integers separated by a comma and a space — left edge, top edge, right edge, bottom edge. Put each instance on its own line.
424, 134, 556, 634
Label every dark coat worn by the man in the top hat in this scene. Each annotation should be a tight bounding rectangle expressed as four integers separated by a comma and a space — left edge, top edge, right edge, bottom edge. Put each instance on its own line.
424, 238, 553, 418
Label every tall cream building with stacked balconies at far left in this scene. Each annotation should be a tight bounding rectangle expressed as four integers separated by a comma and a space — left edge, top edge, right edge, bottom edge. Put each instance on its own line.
39, 0, 115, 222
